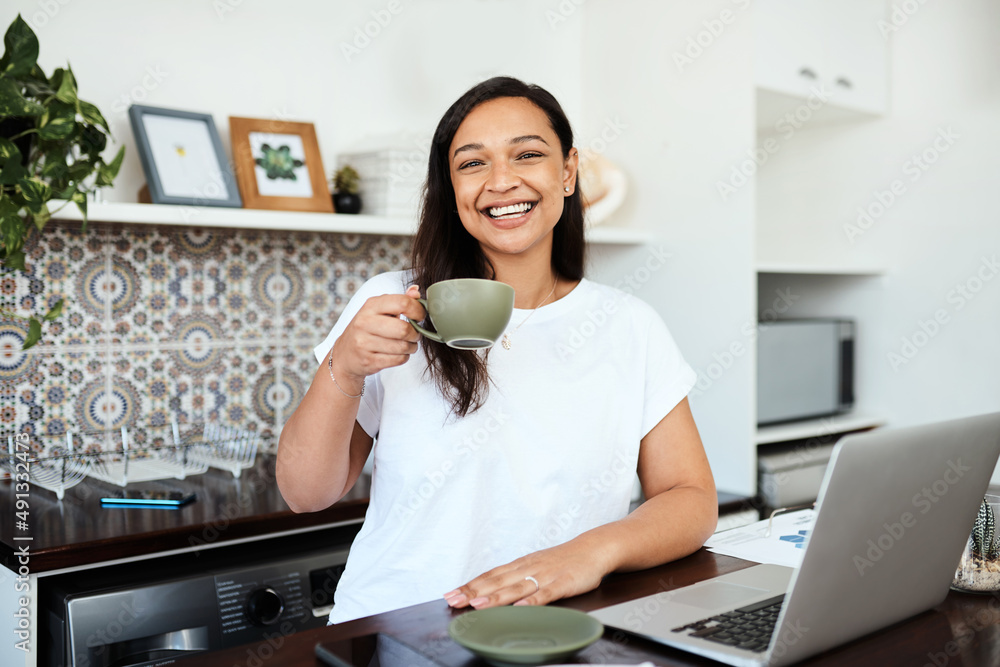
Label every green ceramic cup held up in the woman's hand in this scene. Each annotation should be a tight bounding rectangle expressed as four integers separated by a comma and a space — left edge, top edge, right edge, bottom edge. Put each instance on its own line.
409, 278, 514, 350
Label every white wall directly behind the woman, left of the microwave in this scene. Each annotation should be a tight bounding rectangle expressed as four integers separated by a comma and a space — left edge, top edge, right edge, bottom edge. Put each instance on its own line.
581, 0, 756, 494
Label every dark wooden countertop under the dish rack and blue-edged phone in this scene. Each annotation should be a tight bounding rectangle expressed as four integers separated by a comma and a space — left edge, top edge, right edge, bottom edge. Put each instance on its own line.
0, 455, 370, 574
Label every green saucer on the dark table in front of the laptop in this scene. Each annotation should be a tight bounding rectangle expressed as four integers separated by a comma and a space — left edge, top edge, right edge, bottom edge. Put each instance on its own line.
448, 606, 604, 667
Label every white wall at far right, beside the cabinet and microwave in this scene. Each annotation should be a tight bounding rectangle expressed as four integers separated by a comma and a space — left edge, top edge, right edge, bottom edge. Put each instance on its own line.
758, 0, 1000, 481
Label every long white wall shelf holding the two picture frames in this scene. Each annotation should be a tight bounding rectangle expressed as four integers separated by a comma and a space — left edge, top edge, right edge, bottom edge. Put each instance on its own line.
49, 202, 651, 245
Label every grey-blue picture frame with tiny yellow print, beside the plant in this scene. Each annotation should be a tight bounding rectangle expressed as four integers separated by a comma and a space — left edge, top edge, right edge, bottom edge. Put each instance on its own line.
128, 104, 242, 208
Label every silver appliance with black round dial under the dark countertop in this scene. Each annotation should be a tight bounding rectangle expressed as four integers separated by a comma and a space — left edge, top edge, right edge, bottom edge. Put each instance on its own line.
39, 524, 360, 667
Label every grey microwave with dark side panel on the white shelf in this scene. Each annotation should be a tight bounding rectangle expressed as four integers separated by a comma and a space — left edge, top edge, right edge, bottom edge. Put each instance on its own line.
757, 319, 855, 426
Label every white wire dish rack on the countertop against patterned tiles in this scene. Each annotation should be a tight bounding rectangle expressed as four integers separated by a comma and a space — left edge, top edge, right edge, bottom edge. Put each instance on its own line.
4, 421, 261, 500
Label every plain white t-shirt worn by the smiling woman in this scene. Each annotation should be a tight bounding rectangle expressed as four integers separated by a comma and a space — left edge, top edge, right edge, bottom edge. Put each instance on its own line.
315, 271, 695, 623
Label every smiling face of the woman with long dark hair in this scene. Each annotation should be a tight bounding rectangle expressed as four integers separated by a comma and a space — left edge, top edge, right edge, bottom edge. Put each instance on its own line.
448, 97, 577, 264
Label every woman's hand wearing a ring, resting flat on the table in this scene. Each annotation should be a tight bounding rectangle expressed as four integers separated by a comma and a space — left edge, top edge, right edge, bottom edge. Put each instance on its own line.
444, 536, 613, 609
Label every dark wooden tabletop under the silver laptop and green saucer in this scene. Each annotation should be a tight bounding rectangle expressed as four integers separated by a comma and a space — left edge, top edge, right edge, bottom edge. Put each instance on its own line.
177, 549, 1000, 667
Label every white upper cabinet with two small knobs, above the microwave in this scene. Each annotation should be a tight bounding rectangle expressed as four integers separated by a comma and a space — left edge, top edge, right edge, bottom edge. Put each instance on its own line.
754, 0, 889, 122
